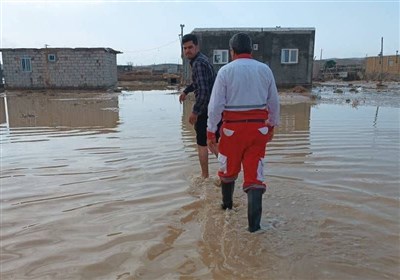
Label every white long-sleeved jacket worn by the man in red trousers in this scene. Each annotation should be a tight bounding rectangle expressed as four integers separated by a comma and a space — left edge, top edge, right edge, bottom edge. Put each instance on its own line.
207, 58, 279, 133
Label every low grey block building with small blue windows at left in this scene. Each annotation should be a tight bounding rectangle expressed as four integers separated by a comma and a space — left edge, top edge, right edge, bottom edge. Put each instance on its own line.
0, 48, 121, 89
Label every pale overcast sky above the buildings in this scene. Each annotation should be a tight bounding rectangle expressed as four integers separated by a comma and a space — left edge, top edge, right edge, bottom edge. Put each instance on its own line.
0, 0, 400, 65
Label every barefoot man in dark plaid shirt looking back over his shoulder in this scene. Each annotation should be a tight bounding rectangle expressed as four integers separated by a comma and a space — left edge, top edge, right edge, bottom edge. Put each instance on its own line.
179, 34, 216, 178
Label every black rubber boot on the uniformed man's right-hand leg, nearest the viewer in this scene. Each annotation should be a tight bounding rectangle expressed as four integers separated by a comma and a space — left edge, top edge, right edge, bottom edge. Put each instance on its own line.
247, 189, 264, 232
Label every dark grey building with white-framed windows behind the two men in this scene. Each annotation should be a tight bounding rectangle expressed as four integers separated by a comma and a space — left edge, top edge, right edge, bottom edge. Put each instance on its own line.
183, 27, 315, 87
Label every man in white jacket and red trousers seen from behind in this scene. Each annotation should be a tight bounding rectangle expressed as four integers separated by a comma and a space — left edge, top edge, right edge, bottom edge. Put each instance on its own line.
207, 33, 279, 232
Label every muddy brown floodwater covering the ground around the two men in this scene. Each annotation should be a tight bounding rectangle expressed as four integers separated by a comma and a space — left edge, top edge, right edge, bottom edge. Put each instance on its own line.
0, 88, 400, 280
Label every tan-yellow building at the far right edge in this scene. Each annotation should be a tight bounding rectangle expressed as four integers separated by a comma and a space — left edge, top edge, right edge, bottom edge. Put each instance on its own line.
365, 55, 400, 81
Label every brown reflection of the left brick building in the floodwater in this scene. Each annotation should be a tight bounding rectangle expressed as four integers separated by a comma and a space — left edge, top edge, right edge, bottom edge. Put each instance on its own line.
0, 94, 118, 128
